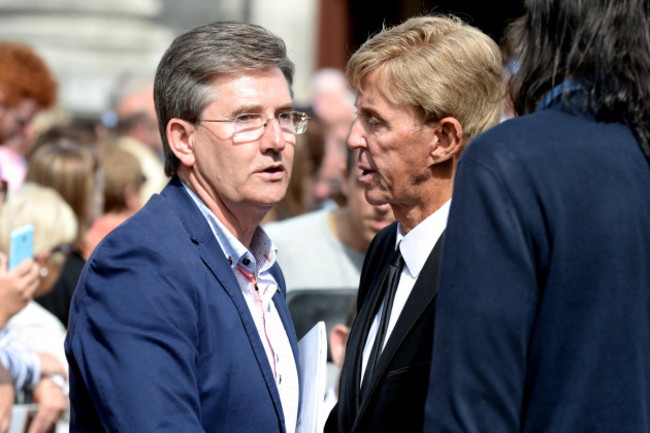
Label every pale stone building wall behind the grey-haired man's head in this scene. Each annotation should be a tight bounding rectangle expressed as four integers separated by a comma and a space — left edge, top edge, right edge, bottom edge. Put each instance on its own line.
0, 0, 317, 117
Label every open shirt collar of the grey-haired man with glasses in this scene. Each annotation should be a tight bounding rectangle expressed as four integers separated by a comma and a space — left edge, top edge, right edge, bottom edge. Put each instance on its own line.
181, 182, 277, 275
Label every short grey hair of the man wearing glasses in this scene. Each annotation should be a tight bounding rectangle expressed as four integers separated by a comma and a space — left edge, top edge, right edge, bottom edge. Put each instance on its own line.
154, 22, 295, 176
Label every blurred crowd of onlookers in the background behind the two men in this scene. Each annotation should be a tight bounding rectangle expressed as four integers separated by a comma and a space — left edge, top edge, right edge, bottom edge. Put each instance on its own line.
0, 41, 394, 432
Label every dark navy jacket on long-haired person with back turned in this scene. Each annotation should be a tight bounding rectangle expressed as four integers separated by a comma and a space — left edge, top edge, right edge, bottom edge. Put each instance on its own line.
425, 93, 650, 433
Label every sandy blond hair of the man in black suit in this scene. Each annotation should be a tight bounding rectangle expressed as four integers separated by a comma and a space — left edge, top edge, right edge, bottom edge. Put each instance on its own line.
347, 16, 505, 144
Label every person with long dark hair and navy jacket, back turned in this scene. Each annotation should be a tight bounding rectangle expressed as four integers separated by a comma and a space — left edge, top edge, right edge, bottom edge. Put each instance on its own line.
424, 0, 650, 433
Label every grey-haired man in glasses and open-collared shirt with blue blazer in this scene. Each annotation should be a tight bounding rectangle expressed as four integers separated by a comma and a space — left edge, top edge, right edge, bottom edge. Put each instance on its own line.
65, 23, 308, 433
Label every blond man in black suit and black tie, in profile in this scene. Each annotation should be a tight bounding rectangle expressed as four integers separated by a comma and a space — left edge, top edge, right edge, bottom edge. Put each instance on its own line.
325, 17, 503, 433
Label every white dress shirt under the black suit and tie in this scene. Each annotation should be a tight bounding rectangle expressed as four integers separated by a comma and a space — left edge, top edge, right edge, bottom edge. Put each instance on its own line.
359, 199, 451, 386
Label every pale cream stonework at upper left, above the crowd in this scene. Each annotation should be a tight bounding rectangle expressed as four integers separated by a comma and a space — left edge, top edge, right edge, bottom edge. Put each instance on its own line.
0, 0, 174, 117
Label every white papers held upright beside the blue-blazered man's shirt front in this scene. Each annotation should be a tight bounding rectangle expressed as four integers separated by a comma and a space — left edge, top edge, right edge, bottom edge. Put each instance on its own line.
296, 321, 327, 433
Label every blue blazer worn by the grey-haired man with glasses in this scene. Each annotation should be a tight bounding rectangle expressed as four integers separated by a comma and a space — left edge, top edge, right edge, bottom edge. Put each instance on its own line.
65, 178, 298, 433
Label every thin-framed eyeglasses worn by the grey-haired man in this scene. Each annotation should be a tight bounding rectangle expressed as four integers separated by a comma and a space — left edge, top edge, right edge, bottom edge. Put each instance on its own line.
199, 111, 309, 143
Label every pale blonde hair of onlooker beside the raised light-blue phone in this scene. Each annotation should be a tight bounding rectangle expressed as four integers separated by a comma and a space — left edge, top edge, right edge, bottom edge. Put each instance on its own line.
0, 182, 77, 257
